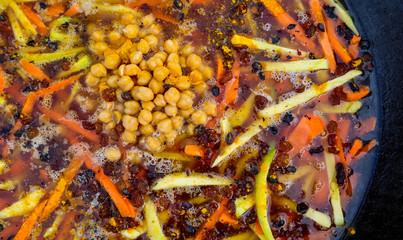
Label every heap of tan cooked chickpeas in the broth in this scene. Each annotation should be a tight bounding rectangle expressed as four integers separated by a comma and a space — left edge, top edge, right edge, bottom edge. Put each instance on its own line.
86, 14, 217, 153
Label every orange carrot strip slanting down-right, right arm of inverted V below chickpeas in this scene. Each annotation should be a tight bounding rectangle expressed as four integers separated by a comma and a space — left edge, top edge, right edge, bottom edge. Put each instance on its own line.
83, 153, 136, 218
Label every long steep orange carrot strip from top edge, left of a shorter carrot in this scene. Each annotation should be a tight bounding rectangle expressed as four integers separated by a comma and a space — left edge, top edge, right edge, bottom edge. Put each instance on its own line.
310, 0, 336, 73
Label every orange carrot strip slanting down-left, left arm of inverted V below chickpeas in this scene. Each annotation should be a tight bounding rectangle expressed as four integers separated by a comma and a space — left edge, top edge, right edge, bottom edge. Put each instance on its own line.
39, 157, 83, 221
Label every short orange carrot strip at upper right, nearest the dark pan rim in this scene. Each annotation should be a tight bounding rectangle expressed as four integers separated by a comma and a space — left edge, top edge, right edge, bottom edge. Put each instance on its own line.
322, 11, 352, 63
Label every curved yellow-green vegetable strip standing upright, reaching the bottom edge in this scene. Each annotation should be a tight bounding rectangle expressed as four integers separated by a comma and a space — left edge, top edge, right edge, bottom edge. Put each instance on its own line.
255, 146, 276, 240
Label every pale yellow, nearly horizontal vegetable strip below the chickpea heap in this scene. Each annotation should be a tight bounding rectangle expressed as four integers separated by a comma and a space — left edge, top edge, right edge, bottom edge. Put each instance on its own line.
152, 172, 231, 190
